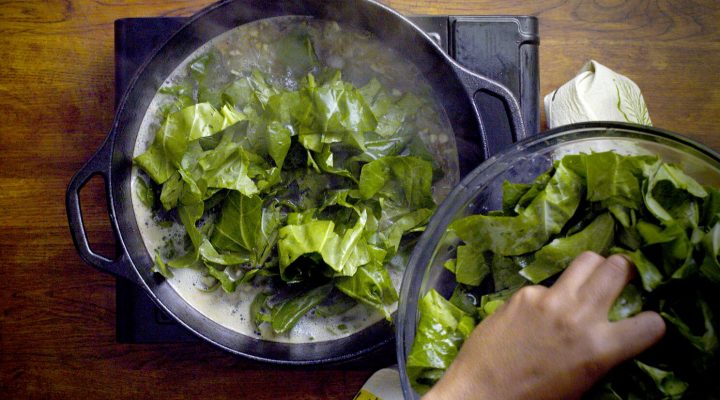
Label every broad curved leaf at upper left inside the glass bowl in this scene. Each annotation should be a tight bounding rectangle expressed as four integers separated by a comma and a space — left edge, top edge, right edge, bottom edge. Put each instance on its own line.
450, 163, 583, 256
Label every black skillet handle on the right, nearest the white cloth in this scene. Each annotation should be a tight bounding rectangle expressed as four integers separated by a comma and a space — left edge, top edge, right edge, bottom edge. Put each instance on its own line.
453, 62, 529, 159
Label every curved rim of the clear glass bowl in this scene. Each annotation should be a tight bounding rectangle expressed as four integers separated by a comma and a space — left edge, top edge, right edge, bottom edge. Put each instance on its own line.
396, 121, 720, 399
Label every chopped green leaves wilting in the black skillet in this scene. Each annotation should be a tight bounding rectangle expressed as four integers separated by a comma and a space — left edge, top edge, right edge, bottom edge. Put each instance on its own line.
134, 35, 443, 334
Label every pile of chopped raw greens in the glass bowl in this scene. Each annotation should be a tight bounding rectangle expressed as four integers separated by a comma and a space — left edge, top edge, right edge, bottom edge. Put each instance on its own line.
407, 152, 720, 399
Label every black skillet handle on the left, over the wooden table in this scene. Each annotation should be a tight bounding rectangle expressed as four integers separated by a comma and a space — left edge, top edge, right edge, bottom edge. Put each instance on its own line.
65, 135, 139, 283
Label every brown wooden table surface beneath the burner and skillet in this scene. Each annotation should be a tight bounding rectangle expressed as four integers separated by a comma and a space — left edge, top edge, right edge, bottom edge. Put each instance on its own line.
0, 0, 720, 399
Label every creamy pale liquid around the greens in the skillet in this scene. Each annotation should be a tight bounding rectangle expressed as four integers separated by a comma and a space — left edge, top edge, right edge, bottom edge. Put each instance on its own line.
131, 17, 458, 343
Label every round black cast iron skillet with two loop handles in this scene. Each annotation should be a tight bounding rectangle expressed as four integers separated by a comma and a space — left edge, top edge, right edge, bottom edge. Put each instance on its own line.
66, 0, 526, 364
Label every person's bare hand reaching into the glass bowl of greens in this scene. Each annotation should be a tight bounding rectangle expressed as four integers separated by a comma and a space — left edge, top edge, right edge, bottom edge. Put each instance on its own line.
424, 252, 665, 400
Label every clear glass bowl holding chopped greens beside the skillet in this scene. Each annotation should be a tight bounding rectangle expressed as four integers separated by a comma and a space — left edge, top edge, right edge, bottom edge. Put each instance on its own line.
396, 122, 720, 399
